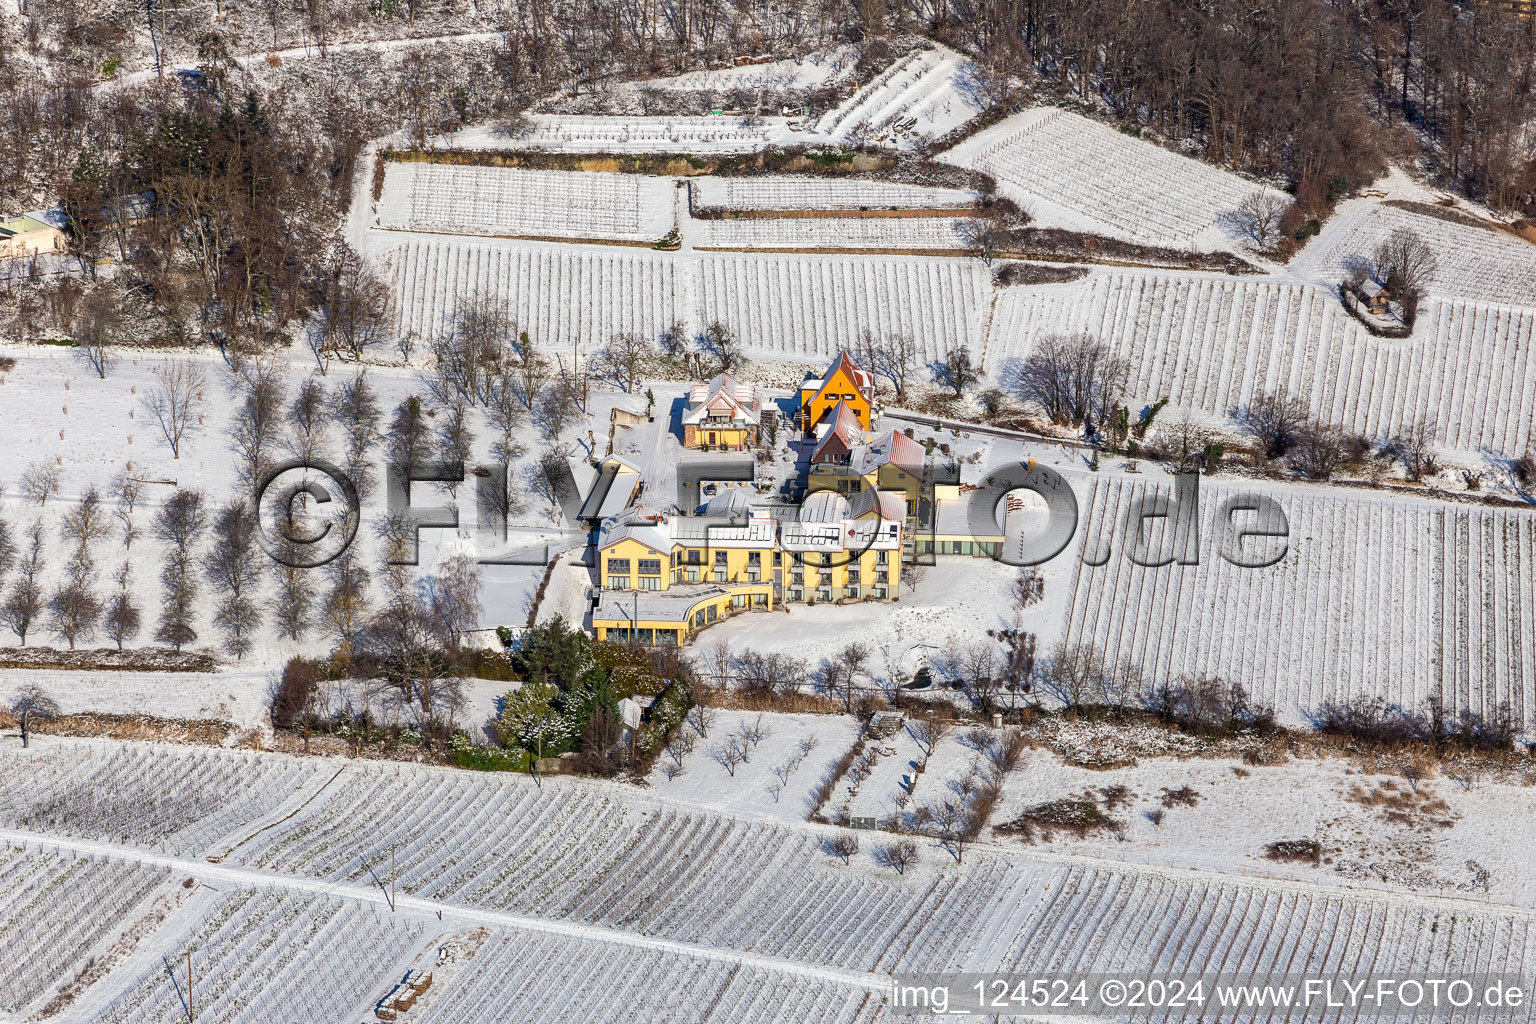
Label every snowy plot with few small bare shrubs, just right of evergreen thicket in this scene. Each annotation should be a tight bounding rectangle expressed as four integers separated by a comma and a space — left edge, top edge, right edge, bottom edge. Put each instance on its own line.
647, 711, 859, 821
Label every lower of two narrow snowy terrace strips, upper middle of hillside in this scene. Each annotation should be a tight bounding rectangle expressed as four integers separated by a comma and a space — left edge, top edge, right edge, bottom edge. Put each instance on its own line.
694, 216, 972, 253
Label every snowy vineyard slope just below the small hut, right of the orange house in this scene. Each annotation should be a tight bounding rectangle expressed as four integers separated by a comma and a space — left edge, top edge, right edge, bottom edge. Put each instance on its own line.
986, 272, 1536, 453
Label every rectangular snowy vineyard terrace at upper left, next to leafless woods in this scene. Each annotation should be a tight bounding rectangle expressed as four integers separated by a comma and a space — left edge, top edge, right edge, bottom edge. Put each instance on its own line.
378, 161, 674, 241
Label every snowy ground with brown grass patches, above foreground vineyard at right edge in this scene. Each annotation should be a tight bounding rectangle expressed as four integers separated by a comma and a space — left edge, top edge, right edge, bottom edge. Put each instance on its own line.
992, 751, 1536, 907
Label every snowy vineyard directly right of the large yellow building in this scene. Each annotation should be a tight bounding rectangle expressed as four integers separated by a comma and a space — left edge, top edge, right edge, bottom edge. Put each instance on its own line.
1066, 481, 1536, 722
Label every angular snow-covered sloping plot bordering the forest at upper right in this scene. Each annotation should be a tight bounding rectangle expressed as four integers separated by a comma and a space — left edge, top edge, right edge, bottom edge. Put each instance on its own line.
942, 107, 1284, 249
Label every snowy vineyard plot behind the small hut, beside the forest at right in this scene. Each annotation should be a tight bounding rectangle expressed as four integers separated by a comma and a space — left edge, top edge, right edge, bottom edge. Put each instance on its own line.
1293, 203, 1536, 306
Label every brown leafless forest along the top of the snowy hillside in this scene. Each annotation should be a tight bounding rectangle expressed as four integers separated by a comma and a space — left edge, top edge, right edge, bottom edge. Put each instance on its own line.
0, 0, 1536, 348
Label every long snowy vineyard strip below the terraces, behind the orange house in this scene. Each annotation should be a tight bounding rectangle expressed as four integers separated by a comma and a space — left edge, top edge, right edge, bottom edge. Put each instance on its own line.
387, 241, 991, 361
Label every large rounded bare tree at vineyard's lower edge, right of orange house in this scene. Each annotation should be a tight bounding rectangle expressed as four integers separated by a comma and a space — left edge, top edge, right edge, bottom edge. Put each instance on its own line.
1011, 333, 1130, 427
